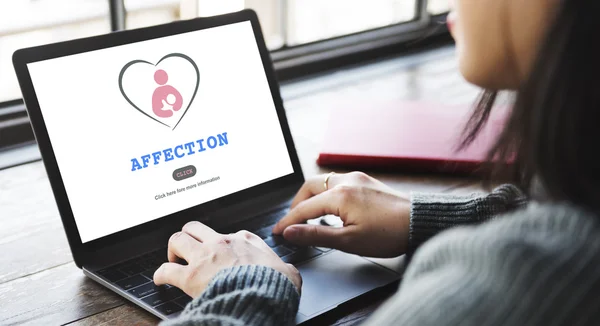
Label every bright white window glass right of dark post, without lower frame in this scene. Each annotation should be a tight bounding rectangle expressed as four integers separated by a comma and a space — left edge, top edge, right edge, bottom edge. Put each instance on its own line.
125, 0, 436, 50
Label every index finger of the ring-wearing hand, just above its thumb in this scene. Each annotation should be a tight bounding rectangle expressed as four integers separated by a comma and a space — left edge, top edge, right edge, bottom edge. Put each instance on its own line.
273, 191, 339, 234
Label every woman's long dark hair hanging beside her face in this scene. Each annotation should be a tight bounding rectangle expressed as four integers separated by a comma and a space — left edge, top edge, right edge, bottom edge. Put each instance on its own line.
462, 0, 600, 211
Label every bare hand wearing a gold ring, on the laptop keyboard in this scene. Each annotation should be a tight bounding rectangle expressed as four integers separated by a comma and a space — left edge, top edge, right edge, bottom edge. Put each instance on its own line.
273, 172, 410, 257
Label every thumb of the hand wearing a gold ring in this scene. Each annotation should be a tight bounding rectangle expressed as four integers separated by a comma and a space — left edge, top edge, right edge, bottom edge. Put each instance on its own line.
283, 224, 354, 249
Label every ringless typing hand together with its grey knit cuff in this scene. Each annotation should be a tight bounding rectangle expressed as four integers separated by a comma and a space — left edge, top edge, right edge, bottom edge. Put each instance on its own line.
154, 222, 302, 325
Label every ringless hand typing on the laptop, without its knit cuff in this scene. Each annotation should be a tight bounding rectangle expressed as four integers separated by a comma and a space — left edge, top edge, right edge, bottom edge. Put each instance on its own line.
154, 222, 302, 298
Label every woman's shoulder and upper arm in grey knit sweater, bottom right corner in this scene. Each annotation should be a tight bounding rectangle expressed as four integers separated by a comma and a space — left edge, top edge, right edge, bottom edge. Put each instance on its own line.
401, 203, 600, 325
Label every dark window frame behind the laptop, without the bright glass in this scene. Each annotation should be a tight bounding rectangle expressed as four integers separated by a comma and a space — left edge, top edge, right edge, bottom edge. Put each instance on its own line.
0, 0, 452, 157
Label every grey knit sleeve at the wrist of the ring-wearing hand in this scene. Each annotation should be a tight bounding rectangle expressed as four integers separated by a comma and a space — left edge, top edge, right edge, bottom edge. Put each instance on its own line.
408, 184, 526, 256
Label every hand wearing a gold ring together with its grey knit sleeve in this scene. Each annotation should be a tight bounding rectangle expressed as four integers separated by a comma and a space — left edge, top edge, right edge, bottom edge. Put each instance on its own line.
273, 172, 526, 258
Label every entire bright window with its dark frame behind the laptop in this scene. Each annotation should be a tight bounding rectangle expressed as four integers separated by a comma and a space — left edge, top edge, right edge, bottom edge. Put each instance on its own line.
0, 0, 449, 157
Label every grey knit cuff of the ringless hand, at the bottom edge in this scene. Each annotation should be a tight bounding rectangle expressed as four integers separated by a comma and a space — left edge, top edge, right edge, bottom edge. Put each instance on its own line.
162, 266, 300, 326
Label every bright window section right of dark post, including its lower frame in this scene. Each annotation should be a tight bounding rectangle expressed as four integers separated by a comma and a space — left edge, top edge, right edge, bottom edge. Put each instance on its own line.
118, 0, 448, 79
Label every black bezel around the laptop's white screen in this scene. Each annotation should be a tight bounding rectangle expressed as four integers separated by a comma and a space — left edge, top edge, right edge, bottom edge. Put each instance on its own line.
13, 9, 304, 267
